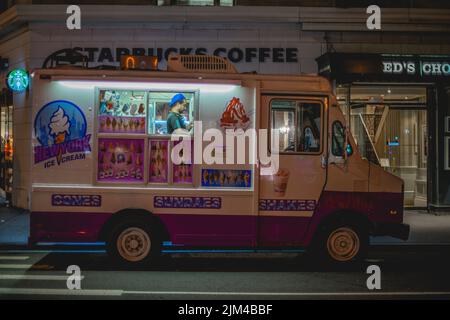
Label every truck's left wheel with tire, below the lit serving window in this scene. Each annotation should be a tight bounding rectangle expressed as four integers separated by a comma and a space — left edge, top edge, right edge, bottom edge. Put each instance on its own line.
106, 219, 161, 267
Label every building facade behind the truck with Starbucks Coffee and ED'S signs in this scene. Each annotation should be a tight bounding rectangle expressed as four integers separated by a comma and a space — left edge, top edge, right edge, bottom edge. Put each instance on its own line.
0, 1, 450, 208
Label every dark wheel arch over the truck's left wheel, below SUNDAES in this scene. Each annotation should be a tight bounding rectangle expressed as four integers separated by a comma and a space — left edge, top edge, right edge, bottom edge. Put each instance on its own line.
98, 208, 169, 242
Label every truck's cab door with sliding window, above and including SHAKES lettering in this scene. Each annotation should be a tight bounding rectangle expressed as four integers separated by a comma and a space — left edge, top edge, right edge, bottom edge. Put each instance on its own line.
258, 95, 327, 246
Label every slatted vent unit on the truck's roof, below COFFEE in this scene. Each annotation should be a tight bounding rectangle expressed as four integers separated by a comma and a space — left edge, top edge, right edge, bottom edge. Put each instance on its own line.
167, 54, 237, 73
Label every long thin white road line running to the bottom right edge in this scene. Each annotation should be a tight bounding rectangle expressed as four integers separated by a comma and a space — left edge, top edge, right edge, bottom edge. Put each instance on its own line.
123, 291, 450, 296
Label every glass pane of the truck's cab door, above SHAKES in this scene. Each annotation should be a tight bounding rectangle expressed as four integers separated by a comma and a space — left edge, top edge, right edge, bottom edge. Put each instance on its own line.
271, 100, 322, 153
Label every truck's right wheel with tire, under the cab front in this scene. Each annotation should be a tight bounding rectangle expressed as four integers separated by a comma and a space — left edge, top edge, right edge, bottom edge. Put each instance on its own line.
308, 222, 369, 266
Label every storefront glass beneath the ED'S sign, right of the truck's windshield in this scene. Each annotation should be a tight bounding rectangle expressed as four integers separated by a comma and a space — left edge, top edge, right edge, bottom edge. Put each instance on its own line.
350, 85, 428, 207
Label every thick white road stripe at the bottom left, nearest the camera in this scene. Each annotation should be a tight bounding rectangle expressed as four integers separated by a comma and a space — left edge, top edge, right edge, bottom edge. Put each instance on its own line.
0, 288, 123, 296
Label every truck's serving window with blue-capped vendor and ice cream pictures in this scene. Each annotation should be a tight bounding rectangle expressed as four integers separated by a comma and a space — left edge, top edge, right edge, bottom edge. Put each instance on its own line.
97, 89, 196, 185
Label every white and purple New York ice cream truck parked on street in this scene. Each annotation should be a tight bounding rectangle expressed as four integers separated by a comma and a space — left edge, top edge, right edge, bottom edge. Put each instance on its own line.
29, 56, 409, 265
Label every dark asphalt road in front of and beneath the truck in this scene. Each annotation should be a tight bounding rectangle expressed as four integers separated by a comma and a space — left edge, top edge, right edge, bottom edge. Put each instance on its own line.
0, 246, 450, 300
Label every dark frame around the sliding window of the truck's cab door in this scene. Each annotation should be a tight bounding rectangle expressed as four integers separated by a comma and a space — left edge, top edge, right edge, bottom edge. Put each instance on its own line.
268, 96, 327, 155
